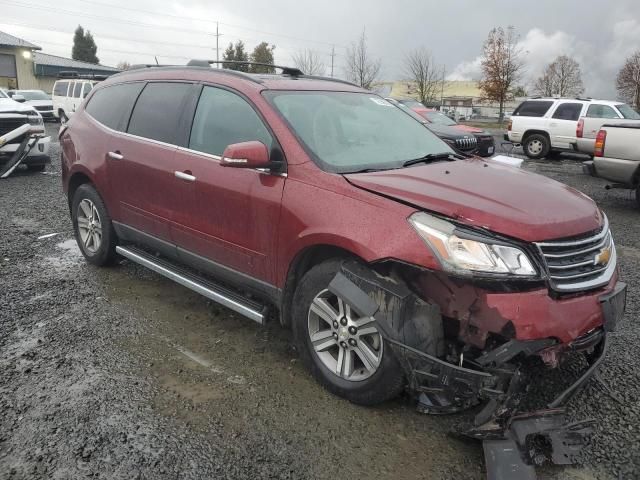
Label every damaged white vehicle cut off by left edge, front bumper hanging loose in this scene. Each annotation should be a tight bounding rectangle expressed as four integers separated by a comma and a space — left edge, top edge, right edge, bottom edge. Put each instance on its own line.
0, 90, 51, 171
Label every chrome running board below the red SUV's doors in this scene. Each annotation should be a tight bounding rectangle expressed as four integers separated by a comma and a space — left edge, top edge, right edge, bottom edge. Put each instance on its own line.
116, 246, 266, 325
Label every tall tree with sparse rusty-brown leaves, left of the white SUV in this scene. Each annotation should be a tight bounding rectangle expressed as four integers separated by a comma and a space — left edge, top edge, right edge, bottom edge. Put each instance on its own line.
480, 27, 524, 120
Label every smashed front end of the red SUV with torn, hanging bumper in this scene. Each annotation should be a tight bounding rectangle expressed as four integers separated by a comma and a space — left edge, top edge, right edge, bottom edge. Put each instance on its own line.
329, 261, 626, 479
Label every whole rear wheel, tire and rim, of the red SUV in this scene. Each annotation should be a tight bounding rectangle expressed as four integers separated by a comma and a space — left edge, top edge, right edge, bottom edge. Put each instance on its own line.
71, 183, 118, 267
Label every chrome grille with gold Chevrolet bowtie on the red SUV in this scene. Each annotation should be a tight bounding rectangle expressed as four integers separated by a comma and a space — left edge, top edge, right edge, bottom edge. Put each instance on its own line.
536, 220, 616, 292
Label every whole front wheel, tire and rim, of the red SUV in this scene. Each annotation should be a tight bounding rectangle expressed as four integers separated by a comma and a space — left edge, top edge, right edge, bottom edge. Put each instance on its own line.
292, 260, 405, 405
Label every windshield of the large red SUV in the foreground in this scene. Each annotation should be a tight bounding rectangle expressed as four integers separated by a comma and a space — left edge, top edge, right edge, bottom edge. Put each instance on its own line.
265, 91, 453, 173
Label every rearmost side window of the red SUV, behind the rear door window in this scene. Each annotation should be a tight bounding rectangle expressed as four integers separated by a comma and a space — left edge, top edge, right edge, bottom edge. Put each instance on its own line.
86, 82, 144, 132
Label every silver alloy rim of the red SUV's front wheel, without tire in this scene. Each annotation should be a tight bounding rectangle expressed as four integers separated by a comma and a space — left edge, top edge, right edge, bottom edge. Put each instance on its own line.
308, 290, 384, 382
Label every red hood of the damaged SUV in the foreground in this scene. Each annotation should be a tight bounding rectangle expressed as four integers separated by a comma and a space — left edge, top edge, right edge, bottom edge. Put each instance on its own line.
345, 158, 603, 242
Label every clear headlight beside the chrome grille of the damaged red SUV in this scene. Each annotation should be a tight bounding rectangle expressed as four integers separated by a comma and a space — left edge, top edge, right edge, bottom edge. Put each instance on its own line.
409, 212, 537, 277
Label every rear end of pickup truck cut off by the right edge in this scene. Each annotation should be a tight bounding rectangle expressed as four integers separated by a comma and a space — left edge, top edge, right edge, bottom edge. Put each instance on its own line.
582, 122, 640, 206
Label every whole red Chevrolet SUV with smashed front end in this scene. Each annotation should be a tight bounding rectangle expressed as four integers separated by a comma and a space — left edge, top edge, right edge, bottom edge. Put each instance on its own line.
60, 62, 626, 466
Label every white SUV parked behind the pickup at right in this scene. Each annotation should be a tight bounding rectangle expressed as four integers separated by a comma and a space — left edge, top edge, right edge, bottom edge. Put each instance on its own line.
506, 98, 640, 159
